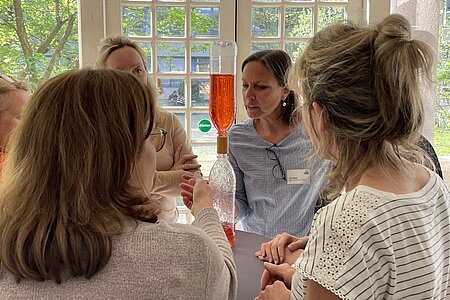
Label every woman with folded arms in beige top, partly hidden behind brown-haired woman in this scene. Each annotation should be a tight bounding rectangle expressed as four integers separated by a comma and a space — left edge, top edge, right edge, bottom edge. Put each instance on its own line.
97, 36, 200, 222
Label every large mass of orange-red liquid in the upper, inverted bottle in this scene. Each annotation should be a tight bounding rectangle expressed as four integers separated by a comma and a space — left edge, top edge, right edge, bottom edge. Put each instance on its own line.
209, 74, 236, 136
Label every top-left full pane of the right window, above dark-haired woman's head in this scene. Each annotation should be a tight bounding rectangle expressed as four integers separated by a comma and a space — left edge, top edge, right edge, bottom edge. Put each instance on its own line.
252, 7, 280, 37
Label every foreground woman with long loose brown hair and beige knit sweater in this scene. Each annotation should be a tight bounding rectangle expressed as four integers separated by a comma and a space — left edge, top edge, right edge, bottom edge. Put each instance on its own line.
0, 70, 237, 299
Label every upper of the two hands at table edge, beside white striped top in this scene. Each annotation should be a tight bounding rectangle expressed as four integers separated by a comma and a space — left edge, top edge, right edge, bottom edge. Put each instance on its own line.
255, 232, 309, 264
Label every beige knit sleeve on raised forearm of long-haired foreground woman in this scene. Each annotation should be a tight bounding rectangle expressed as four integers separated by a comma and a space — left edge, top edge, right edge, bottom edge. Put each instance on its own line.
192, 208, 238, 300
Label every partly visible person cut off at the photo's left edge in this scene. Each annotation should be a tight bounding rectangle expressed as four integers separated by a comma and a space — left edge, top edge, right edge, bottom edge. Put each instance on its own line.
0, 74, 28, 170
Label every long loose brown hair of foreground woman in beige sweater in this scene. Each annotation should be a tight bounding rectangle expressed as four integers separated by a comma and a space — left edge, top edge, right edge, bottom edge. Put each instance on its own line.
0, 70, 159, 283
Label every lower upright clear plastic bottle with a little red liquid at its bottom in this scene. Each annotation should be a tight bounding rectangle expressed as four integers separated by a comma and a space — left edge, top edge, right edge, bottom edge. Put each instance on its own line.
209, 136, 236, 247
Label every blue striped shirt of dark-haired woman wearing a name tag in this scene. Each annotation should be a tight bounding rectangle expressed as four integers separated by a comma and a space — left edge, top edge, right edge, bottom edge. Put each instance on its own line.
229, 119, 331, 237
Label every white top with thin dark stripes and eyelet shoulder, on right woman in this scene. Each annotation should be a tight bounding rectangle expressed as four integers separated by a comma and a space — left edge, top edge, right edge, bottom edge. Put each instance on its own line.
292, 171, 450, 300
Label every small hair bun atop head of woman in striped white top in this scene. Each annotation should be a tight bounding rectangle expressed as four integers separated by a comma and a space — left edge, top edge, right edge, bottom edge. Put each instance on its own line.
375, 14, 411, 41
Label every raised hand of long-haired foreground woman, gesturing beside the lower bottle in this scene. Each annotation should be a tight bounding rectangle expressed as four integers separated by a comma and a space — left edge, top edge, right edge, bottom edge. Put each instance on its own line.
180, 172, 213, 216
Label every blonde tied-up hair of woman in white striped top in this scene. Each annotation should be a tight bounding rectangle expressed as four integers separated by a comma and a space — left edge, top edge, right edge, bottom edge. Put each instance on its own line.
289, 15, 433, 198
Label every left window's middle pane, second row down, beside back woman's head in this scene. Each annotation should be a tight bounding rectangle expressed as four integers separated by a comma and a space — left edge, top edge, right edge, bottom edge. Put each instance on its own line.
157, 42, 186, 73
